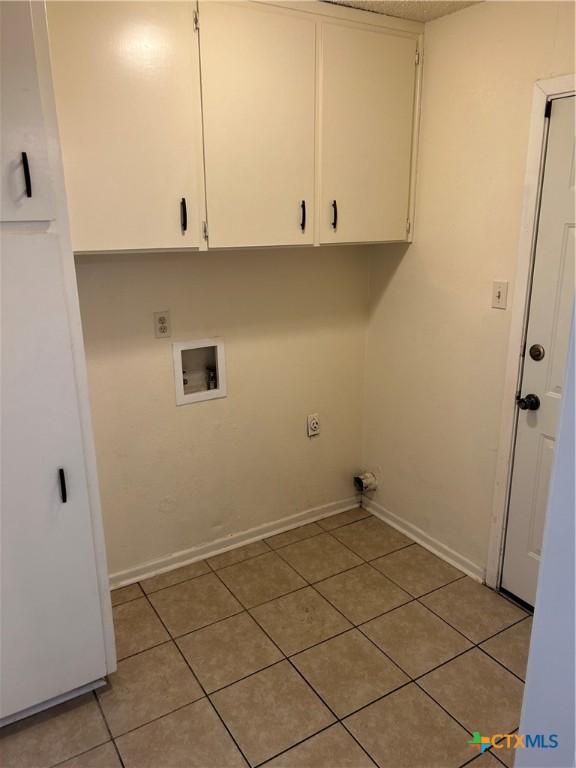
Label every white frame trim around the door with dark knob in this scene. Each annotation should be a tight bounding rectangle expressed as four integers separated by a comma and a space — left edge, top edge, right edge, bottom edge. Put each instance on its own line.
486, 74, 576, 589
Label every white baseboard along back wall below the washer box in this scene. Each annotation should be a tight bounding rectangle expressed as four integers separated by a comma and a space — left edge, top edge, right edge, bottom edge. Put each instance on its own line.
110, 496, 360, 589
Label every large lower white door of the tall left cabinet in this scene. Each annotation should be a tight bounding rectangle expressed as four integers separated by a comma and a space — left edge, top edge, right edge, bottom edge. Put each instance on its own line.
0, 233, 106, 717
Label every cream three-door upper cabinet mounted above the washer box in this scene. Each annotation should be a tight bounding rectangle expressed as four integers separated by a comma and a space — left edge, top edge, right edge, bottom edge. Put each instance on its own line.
47, 0, 422, 251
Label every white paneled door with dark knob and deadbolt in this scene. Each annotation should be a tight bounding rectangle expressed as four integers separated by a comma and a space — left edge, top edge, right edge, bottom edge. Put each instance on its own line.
502, 97, 575, 605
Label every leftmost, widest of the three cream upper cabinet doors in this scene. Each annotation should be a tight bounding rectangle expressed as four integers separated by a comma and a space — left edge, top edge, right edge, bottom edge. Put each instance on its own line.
48, 2, 203, 251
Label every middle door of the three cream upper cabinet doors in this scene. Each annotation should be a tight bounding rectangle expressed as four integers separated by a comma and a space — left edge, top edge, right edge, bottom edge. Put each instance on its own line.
200, 2, 315, 248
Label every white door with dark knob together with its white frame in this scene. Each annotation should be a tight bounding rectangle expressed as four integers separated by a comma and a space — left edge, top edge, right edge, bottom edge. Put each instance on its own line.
486, 78, 576, 607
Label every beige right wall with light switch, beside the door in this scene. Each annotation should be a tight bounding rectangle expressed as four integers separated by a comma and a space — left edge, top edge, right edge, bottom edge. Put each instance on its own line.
363, 2, 574, 567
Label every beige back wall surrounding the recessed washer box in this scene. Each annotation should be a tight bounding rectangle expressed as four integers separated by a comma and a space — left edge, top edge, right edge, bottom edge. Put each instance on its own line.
77, 248, 371, 574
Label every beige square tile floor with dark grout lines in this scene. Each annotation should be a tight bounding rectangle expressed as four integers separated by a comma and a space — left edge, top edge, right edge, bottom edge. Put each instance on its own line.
0, 509, 531, 768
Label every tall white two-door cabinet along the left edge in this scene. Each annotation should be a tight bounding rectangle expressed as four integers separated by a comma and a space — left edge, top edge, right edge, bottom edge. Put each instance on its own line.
0, 2, 115, 724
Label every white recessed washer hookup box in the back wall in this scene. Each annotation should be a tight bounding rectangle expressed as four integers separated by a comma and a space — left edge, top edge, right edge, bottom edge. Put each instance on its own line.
172, 339, 227, 405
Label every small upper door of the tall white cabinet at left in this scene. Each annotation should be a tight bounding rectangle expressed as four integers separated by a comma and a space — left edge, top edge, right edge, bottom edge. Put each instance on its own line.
0, 2, 54, 221
